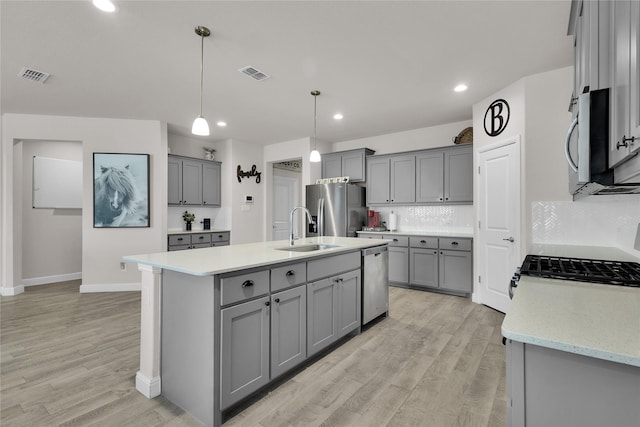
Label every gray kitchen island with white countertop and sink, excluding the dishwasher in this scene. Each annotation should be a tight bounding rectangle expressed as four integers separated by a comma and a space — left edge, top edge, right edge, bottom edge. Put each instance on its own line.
124, 237, 386, 425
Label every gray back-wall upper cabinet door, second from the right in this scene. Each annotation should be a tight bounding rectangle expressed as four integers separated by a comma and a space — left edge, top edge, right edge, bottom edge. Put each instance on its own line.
416, 151, 444, 203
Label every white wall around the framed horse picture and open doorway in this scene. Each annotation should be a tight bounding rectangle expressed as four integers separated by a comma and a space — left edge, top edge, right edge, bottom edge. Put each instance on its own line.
1, 114, 167, 295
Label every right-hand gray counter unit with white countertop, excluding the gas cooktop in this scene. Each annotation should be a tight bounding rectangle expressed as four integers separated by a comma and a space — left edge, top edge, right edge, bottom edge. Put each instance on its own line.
502, 245, 640, 427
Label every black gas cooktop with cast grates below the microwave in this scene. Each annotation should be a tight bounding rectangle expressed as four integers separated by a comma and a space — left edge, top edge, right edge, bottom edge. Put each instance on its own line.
520, 255, 640, 287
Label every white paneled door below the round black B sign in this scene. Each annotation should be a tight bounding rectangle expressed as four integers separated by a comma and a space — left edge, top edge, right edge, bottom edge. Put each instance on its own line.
477, 137, 521, 313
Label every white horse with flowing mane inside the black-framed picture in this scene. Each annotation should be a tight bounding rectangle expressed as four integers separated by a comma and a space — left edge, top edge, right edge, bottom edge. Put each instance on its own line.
94, 165, 140, 227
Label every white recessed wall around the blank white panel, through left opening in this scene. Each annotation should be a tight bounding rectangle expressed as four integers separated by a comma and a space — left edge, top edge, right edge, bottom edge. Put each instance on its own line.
21, 141, 82, 285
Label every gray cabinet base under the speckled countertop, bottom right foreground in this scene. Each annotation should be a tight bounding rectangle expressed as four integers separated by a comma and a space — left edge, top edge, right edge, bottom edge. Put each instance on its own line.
506, 342, 640, 427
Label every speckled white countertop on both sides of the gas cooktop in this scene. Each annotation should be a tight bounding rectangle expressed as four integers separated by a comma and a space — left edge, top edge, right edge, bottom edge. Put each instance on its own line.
502, 245, 640, 367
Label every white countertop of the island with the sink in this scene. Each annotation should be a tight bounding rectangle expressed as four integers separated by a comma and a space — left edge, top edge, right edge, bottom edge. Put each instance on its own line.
123, 236, 387, 276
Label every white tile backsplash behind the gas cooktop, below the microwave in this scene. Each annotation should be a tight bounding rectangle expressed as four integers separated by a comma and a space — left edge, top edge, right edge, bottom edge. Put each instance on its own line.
531, 195, 640, 251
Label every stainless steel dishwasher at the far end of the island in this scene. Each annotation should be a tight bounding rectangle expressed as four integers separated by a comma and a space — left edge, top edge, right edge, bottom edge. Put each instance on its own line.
362, 245, 389, 325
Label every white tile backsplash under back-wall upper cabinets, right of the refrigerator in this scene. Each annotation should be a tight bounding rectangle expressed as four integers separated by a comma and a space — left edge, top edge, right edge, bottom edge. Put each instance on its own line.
371, 205, 473, 232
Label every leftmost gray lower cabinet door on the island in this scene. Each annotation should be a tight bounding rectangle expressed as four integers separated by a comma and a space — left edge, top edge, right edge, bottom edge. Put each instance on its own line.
220, 294, 270, 410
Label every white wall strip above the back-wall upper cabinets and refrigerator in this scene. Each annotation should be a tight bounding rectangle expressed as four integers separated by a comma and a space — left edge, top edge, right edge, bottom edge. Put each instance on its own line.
331, 120, 473, 154
